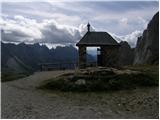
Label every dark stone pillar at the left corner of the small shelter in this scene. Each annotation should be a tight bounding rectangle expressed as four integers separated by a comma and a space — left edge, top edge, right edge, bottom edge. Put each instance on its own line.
78, 46, 86, 69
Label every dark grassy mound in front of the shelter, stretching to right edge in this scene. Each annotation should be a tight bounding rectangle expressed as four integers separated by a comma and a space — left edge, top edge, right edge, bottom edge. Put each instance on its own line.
39, 66, 159, 91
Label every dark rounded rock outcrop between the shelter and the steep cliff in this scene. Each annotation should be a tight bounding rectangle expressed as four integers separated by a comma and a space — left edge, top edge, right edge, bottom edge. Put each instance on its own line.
118, 41, 134, 66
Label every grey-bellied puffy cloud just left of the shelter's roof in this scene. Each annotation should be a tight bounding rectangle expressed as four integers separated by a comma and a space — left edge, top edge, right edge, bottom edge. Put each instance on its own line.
40, 20, 81, 44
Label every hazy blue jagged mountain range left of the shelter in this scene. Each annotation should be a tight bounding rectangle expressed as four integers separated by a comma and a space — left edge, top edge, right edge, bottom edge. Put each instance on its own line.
1, 43, 94, 73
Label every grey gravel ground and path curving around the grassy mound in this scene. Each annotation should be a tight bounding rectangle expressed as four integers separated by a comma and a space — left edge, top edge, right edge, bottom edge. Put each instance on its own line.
1, 71, 159, 119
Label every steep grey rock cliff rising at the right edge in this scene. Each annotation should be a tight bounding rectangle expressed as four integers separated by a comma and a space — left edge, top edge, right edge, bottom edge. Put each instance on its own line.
134, 12, 159, 64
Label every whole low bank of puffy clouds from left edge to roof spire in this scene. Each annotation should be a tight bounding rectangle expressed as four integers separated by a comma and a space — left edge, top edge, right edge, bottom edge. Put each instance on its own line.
0, 15, 87, 44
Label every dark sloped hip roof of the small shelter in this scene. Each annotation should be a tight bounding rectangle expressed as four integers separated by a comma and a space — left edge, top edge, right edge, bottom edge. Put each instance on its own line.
76, 32, 119, 46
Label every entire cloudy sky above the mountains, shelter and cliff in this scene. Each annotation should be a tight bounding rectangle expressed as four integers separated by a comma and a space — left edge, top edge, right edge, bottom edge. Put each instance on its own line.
0, 0, 159, 47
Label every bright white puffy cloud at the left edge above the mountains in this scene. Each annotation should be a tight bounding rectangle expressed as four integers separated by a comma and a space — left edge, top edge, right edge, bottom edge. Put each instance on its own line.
0, 16, 42, 42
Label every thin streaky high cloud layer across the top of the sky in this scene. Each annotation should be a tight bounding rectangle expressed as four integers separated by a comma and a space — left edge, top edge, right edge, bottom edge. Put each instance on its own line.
2, 0, 159, 35
